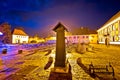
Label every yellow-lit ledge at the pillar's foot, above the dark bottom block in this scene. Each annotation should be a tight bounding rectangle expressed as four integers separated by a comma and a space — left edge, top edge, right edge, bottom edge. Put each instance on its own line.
51, 63, 70, 73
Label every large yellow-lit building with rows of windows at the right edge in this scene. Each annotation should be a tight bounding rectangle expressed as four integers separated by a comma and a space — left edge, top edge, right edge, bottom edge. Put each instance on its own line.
97, 11, 120, 44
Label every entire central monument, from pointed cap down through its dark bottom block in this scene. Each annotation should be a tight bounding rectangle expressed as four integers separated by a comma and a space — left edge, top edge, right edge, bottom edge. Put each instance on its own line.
48, 22, 72, 80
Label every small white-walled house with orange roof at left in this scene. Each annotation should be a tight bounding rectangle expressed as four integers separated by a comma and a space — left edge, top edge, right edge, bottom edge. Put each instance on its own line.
12, 29, 29, 43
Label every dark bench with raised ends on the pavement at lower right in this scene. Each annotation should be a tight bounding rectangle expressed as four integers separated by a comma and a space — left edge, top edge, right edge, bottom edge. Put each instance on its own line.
89, 62, 115, 77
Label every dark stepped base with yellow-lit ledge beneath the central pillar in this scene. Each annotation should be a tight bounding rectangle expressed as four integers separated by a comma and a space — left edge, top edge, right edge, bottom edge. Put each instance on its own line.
48, 63, 72, 80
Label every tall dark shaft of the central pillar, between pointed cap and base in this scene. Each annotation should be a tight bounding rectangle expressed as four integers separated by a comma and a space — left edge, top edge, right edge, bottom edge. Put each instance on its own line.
55, 30, 66, 67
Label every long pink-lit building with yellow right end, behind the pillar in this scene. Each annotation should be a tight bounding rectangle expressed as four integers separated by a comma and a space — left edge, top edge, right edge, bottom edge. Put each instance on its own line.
66, 27, 98, 43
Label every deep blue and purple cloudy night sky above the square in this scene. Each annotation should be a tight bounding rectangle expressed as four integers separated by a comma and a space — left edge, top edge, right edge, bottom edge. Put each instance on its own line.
0, 0, 120, 37
